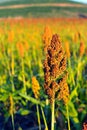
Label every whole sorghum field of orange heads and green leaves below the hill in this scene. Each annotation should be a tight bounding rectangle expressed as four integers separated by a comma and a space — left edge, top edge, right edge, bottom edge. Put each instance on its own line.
0, 18, 87, 130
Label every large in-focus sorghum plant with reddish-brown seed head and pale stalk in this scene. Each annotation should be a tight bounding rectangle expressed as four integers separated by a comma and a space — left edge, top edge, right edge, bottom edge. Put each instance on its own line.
44, 34, 69, 130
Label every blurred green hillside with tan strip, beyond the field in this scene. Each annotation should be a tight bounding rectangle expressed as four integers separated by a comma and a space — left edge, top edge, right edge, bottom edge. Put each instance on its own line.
0, 0, 87, 18
